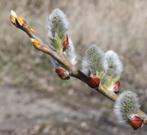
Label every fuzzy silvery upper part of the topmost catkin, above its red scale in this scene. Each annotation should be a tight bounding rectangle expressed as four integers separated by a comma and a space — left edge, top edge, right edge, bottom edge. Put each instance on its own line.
48, 9, 69, 39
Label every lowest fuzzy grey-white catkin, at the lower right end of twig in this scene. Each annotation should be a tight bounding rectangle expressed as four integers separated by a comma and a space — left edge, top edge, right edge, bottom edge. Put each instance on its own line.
114, 91, 140, 123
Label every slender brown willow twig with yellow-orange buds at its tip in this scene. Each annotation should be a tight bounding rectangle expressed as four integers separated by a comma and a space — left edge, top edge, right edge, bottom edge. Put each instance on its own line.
10, 11, 147, 125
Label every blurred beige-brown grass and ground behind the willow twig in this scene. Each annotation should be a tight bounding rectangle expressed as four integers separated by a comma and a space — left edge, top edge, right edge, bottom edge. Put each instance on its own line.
0, 0, 147, 135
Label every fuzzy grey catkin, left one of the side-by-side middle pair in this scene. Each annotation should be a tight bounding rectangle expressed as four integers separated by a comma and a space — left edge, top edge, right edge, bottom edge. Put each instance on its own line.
82, 44, 107, 75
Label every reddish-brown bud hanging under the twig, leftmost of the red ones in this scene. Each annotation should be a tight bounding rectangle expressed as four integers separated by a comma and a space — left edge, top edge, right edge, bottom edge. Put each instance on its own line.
55, 67, 70, 80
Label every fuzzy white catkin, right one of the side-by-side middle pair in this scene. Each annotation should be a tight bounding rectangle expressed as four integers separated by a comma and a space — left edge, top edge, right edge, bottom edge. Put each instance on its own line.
104, 50, 123, 79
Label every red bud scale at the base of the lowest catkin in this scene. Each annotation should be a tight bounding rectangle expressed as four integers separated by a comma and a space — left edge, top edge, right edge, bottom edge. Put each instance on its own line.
129, 115, 143, 130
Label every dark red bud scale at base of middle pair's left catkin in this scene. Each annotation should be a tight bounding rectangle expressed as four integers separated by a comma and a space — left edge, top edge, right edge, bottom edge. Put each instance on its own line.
87, 75, 100, 88
